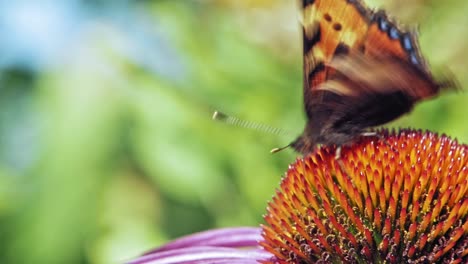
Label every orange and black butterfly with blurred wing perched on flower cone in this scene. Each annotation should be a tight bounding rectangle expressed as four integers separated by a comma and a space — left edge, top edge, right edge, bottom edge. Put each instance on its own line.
278, 0, 455, 155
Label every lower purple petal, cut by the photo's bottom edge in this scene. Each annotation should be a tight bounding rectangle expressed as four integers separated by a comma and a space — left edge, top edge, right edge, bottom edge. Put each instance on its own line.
127, 246, 272, 264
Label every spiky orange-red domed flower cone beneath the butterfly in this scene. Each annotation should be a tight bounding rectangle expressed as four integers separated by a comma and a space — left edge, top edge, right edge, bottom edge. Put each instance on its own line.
260, 130, 468, 263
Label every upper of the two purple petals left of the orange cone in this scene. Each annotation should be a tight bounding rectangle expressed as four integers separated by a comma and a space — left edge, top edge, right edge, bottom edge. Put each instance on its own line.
145, 227, 262, 255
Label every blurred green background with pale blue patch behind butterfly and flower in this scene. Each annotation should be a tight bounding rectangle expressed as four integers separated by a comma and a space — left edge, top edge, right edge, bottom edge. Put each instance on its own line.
0, 0, 468, 264
